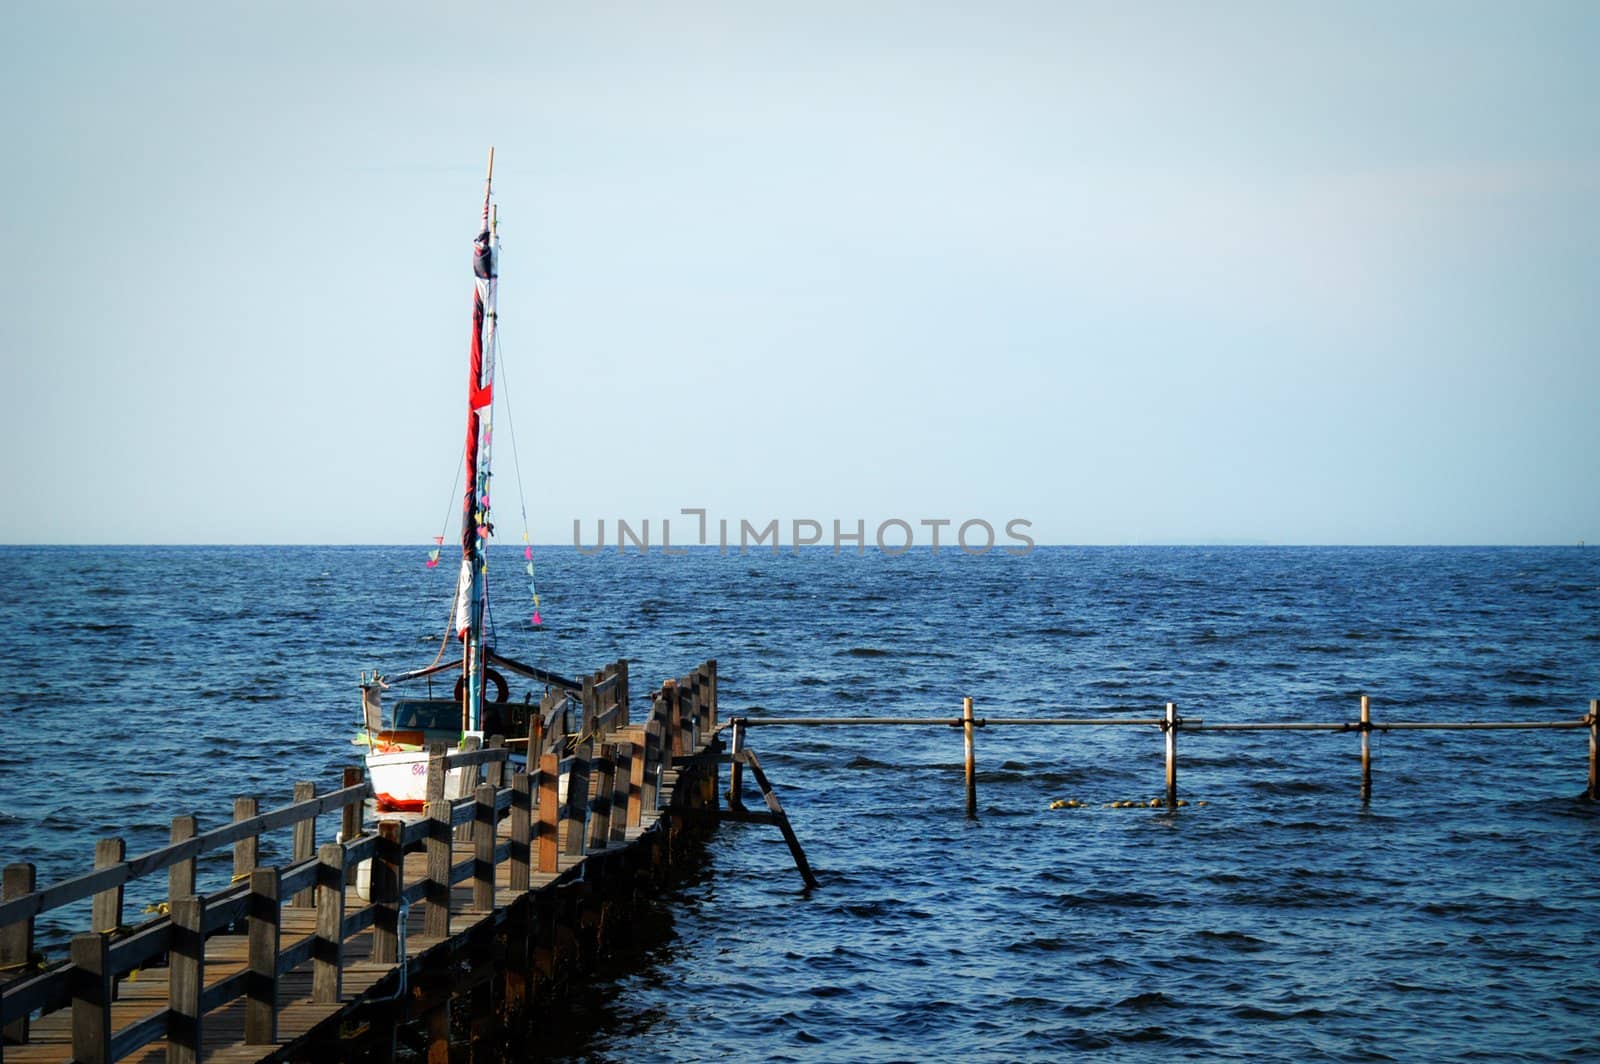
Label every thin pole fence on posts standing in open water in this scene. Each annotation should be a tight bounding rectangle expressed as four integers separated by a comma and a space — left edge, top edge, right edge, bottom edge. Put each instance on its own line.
722, 694, 1600, 816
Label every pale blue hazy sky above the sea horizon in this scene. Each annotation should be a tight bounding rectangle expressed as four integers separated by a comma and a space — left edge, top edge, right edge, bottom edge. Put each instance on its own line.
0, 0, 1600, 544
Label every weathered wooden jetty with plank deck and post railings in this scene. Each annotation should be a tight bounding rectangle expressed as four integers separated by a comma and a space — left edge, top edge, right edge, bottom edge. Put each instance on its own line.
0, 661, 720, 1064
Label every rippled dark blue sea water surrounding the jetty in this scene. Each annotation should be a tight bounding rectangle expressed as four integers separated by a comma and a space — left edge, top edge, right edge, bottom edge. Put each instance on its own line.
0, 547, 1600, 1061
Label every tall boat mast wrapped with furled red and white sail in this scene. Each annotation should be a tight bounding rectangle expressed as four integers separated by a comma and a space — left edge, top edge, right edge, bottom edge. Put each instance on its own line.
456, 147, 498, 731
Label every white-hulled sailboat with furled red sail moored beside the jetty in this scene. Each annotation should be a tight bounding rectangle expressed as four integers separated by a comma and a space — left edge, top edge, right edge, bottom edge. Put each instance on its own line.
355, 147, 581, 811
